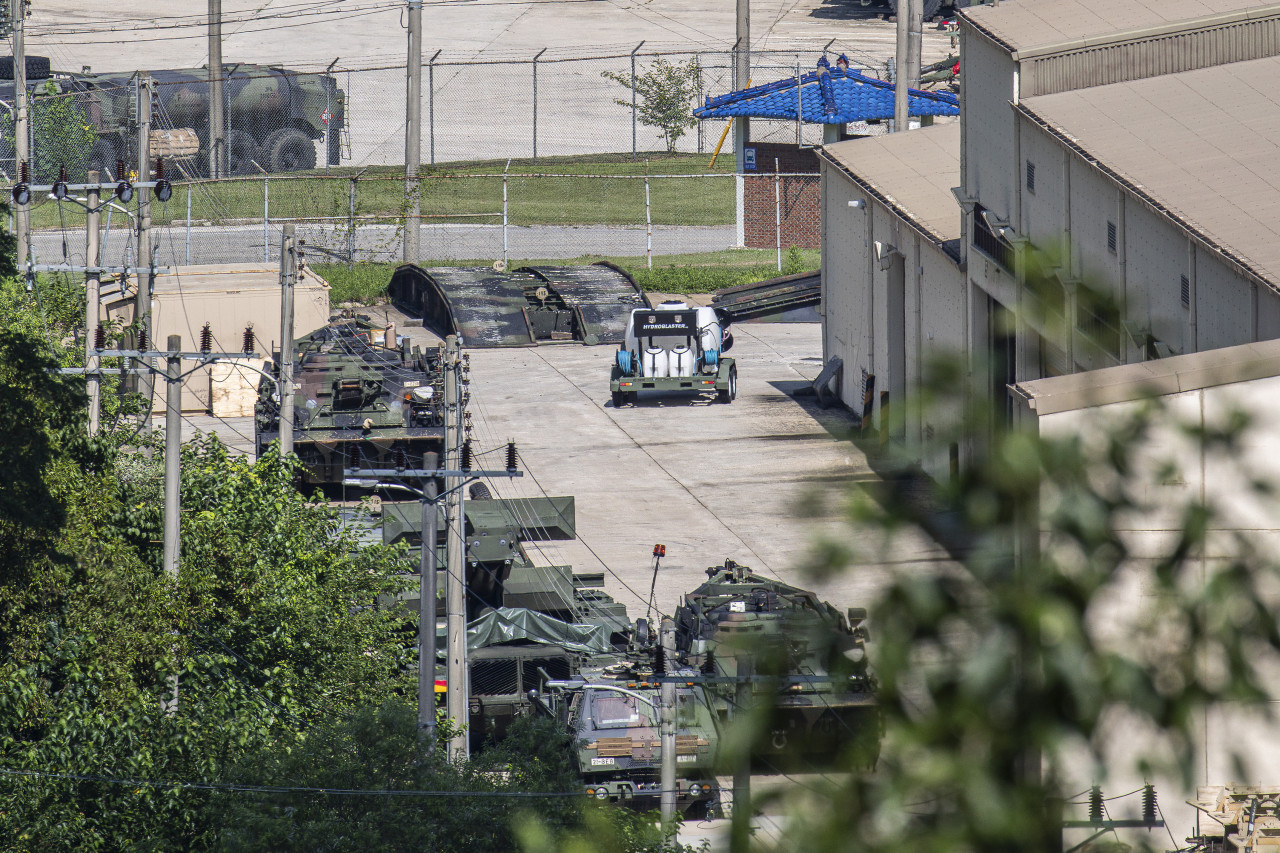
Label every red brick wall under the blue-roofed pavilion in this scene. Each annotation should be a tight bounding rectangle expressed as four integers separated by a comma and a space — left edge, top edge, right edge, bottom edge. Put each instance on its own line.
744, 142, 822, 248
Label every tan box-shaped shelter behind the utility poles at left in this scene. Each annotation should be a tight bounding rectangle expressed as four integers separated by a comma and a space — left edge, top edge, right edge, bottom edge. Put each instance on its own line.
102, 264, 329, 418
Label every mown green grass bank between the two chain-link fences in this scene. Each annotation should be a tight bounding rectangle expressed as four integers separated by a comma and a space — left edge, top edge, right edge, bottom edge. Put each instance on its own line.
32, 154, 735, 229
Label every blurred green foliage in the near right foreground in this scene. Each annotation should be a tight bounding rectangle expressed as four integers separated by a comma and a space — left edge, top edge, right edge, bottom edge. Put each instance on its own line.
757, 333, 1280, 853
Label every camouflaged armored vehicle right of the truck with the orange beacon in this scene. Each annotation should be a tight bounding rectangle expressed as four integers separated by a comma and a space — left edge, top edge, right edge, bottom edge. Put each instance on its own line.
676, 560, 879, 770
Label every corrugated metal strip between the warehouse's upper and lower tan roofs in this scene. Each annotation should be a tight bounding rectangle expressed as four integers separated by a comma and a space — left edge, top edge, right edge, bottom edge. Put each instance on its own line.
1020, 17, 1280, 97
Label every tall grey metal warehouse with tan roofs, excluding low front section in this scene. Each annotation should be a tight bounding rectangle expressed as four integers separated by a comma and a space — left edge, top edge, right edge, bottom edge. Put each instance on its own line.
822, 0, 1280, 475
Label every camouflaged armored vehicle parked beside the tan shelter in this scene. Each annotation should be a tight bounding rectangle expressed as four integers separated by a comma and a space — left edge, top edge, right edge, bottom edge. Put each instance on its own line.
253, 318, 444, 487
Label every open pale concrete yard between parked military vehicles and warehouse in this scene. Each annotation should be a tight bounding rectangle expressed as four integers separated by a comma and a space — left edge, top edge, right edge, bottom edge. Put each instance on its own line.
455, 323, 942, 617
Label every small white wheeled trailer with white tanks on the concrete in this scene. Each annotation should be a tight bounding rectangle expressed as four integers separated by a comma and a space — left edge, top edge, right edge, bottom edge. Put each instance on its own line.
609, 301, 737, 409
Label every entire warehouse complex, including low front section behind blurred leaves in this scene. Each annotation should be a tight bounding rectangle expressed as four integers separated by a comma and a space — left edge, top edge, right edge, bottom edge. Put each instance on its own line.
820, 0, 1280, 843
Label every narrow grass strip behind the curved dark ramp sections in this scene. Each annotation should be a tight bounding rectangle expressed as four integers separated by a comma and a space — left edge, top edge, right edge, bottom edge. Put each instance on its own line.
312, 247, 822, 305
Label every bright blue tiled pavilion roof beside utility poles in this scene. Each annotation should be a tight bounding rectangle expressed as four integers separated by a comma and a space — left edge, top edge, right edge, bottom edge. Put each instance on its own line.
694, 58, 960, 124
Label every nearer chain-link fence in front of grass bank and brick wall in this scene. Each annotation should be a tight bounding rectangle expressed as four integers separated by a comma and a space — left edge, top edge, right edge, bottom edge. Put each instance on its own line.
32, 173, 817, 266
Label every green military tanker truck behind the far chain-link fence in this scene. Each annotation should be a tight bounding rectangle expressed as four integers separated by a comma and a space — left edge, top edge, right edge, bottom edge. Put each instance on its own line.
0, 58, 346, 174
